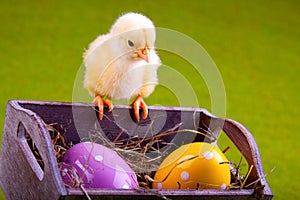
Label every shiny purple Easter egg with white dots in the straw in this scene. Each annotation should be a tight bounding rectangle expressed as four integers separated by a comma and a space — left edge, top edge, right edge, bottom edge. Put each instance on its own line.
60, 142, 138, 189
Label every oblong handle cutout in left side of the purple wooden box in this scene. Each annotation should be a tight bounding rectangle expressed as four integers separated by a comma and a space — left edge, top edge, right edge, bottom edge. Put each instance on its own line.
17, 122, 45, 181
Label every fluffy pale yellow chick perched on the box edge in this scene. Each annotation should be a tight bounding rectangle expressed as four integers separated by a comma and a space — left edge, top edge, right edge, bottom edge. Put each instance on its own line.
83, 13, 161, 121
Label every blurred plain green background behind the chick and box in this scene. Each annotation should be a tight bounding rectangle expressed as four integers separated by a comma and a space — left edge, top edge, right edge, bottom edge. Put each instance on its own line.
0, 0, 300, 199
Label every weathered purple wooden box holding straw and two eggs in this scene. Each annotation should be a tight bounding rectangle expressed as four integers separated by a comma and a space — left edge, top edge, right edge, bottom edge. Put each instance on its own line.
0, 100, 273, 199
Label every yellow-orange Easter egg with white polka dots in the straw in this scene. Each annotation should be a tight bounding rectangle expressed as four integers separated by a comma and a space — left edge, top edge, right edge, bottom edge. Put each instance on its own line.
153, 142, 230, 189
